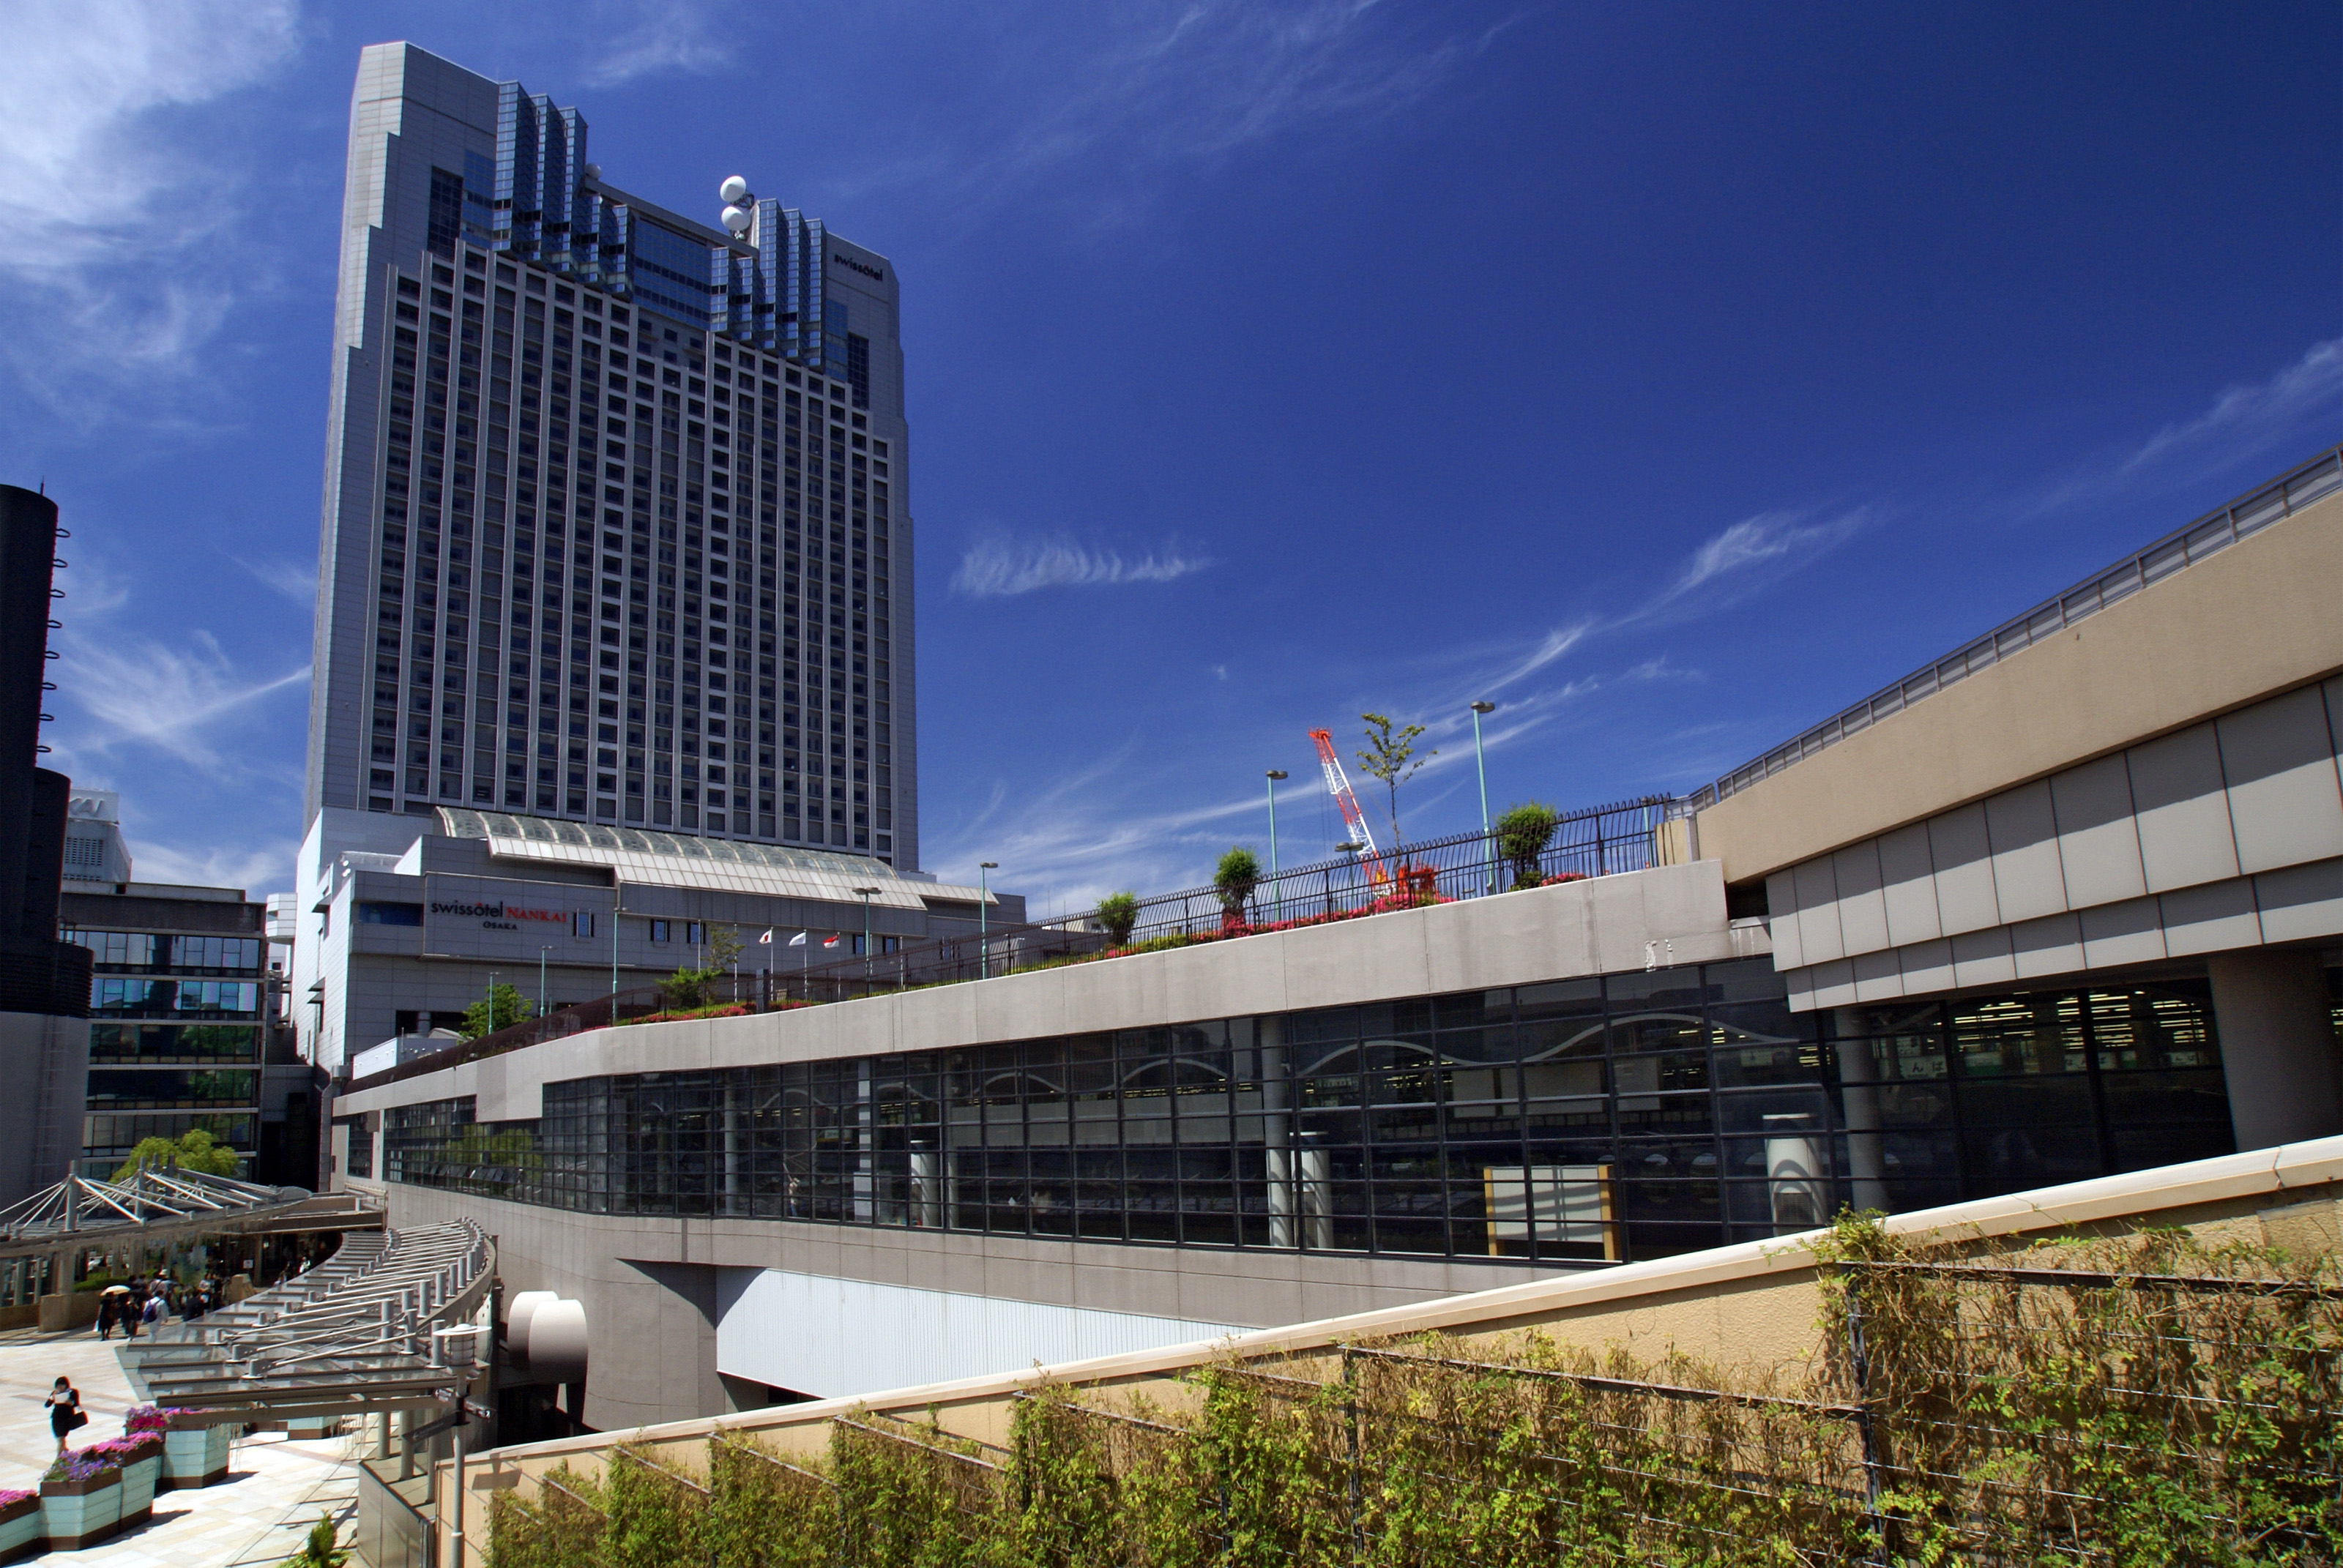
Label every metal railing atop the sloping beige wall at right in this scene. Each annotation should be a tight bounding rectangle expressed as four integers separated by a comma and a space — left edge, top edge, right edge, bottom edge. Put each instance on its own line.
1685, 448, 2343, 811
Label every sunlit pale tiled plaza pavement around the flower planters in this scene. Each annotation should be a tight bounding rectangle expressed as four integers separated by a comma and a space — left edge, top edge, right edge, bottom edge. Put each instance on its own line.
0, 1329, 359, 1568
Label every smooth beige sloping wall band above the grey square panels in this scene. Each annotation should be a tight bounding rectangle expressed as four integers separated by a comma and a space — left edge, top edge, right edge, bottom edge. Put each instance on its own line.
1701, 495, 2343, 884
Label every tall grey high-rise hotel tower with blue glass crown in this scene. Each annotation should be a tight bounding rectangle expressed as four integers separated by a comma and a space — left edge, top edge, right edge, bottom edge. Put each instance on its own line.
307, 45, 918, 870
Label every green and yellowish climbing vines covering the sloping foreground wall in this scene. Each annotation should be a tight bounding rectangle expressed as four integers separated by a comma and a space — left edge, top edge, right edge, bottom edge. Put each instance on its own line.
490, 1217, 2343, 1568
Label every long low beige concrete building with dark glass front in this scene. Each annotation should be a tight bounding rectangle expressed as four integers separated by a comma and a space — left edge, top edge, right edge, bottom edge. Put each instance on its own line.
335, 452, 2343, 1427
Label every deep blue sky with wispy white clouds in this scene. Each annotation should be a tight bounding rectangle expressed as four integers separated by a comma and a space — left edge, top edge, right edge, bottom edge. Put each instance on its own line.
0, 0, 2343, 914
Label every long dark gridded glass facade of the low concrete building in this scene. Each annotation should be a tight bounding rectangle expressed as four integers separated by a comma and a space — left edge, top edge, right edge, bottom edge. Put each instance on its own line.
384, 959, 2230, 1263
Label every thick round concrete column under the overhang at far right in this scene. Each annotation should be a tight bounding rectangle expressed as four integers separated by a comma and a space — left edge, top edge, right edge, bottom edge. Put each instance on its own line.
2205, 949, 2343, 1149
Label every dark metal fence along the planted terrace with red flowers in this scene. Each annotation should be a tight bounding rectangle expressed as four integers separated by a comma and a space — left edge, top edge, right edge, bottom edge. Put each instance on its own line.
342, 794, 1677, 1092
